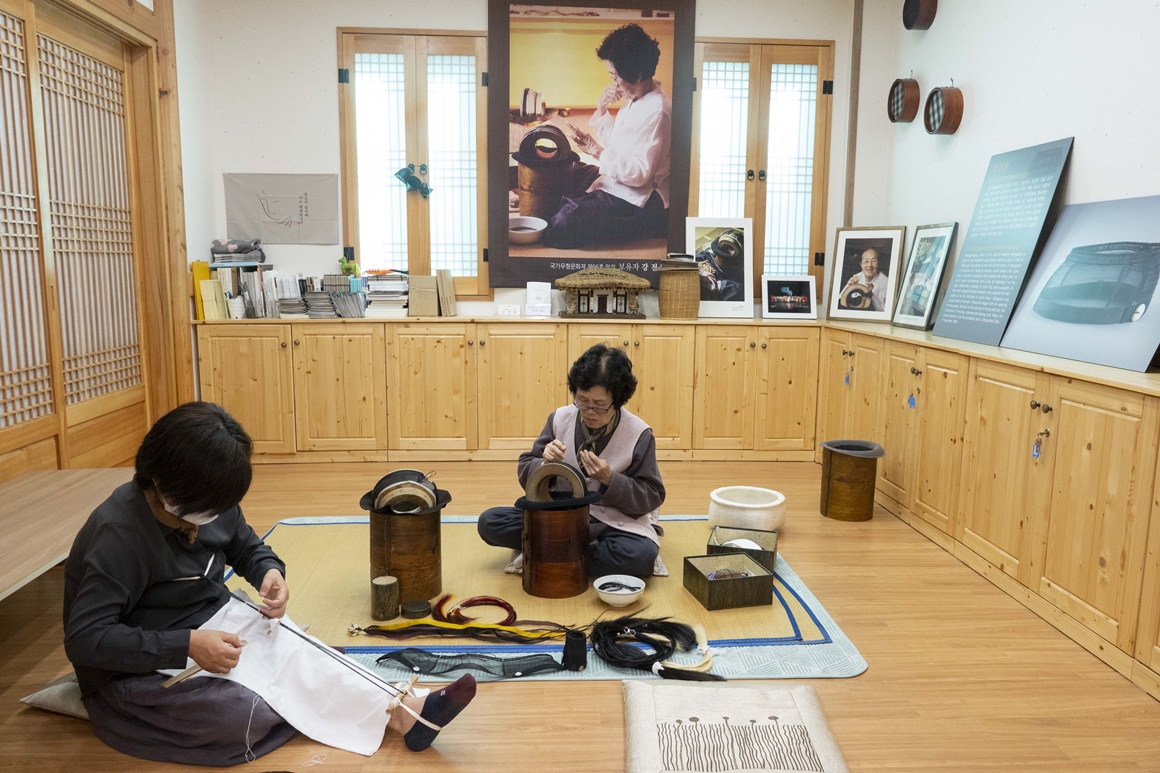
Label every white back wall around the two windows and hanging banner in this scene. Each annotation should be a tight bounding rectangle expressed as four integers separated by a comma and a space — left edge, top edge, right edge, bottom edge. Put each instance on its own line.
174, 0, 853, 303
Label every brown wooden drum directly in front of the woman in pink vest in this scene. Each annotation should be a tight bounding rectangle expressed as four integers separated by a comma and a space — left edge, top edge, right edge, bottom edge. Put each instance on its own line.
523, 505, 588, 599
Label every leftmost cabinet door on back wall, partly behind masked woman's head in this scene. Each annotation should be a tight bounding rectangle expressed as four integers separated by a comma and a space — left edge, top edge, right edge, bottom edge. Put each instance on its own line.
197, 325, 295, 454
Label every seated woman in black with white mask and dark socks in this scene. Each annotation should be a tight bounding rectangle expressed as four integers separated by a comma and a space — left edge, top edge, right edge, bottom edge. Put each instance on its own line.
64, 403, 474, 765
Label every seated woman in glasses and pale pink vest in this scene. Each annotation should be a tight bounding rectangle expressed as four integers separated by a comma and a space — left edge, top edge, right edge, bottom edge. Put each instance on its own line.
478, 344, 665, 578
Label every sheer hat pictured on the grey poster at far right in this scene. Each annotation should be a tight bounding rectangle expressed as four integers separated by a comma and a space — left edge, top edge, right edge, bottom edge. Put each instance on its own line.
1032, 241, 1160, 325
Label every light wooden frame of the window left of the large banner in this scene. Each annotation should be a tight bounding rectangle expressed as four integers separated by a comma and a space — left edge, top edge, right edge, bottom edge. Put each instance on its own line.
336, 27, 494, 301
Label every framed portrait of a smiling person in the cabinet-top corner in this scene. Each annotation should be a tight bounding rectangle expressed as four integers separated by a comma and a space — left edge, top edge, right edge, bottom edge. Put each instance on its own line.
829, 225, 906, 323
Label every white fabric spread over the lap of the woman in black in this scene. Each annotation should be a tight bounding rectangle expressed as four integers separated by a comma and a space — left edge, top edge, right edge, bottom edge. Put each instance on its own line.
162, 599, 394, 757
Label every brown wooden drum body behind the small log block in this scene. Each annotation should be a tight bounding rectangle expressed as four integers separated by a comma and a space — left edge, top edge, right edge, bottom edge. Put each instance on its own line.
370, 510, 443, 601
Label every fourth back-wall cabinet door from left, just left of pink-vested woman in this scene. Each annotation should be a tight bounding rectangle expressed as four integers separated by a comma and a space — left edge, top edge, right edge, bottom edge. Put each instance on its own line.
476, 323, 571, 449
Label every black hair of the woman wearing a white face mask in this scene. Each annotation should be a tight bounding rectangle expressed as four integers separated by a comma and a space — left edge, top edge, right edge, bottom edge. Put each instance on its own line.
133, 403, 254, 515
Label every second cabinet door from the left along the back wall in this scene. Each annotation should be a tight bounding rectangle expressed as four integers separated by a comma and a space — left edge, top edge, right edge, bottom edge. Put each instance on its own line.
292, 323, 386, 450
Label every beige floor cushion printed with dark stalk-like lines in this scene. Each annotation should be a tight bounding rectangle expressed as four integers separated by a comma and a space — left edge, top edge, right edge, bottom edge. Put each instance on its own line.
624, 681, 849, 773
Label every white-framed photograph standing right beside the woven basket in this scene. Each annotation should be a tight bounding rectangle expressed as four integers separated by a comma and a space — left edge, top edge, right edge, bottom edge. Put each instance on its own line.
684, 217, 753, 318
